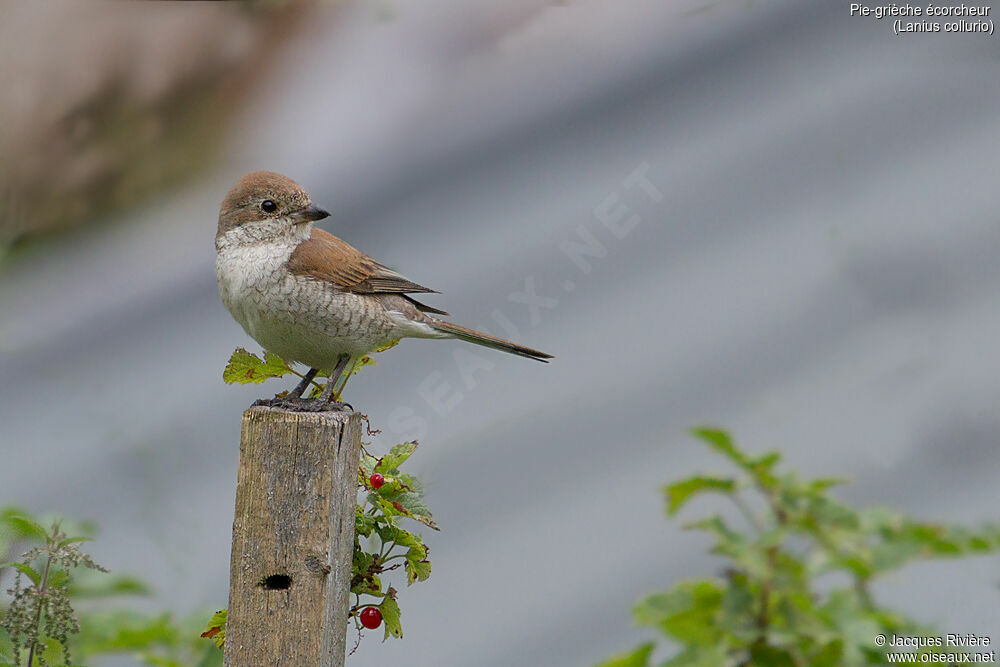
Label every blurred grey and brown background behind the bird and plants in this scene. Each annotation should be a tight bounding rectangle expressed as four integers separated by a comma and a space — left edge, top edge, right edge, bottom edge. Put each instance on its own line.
0, 0, 1000, 667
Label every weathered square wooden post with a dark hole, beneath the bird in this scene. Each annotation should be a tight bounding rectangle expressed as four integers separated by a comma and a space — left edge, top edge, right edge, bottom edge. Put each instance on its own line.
225, 406, 361, 667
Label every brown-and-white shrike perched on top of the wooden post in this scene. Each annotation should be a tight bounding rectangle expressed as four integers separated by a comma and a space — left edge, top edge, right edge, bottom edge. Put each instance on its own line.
215, 171, 552, 401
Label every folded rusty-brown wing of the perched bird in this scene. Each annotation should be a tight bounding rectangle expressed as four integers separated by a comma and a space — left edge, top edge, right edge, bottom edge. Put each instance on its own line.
288, 229, 437, 294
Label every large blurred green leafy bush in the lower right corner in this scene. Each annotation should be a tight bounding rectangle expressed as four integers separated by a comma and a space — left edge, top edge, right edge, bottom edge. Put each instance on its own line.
599, 428, 1000, 667
